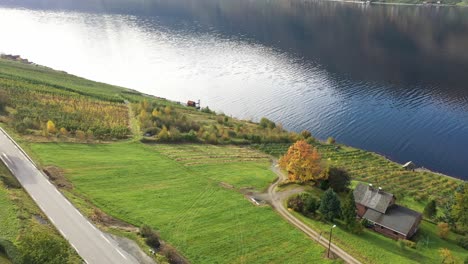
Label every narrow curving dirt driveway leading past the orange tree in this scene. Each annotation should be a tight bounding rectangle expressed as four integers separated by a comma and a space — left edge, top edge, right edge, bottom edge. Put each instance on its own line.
268, 161, 361, 264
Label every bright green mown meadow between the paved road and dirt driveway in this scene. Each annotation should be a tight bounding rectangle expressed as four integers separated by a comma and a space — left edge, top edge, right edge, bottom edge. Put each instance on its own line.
30, 142, 325, 263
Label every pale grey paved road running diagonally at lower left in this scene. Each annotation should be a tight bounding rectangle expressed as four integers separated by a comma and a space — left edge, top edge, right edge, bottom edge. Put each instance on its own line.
0, 128, 138, 264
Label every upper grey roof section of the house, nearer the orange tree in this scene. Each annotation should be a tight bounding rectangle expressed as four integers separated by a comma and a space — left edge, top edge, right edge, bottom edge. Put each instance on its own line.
354, 183, 393, 214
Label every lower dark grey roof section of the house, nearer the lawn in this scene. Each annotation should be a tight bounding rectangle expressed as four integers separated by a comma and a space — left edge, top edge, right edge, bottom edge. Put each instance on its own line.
362, 205, 421, 236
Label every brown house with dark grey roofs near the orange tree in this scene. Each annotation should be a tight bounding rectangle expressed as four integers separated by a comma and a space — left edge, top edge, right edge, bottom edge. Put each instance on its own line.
354, 183, 422, 239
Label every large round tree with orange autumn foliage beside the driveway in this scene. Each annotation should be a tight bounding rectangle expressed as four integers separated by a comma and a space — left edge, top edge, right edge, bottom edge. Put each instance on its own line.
279, 140, 326, 182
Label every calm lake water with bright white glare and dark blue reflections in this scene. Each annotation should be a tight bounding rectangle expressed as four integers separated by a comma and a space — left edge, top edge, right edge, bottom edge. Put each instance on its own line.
0, 0, 468, 179
